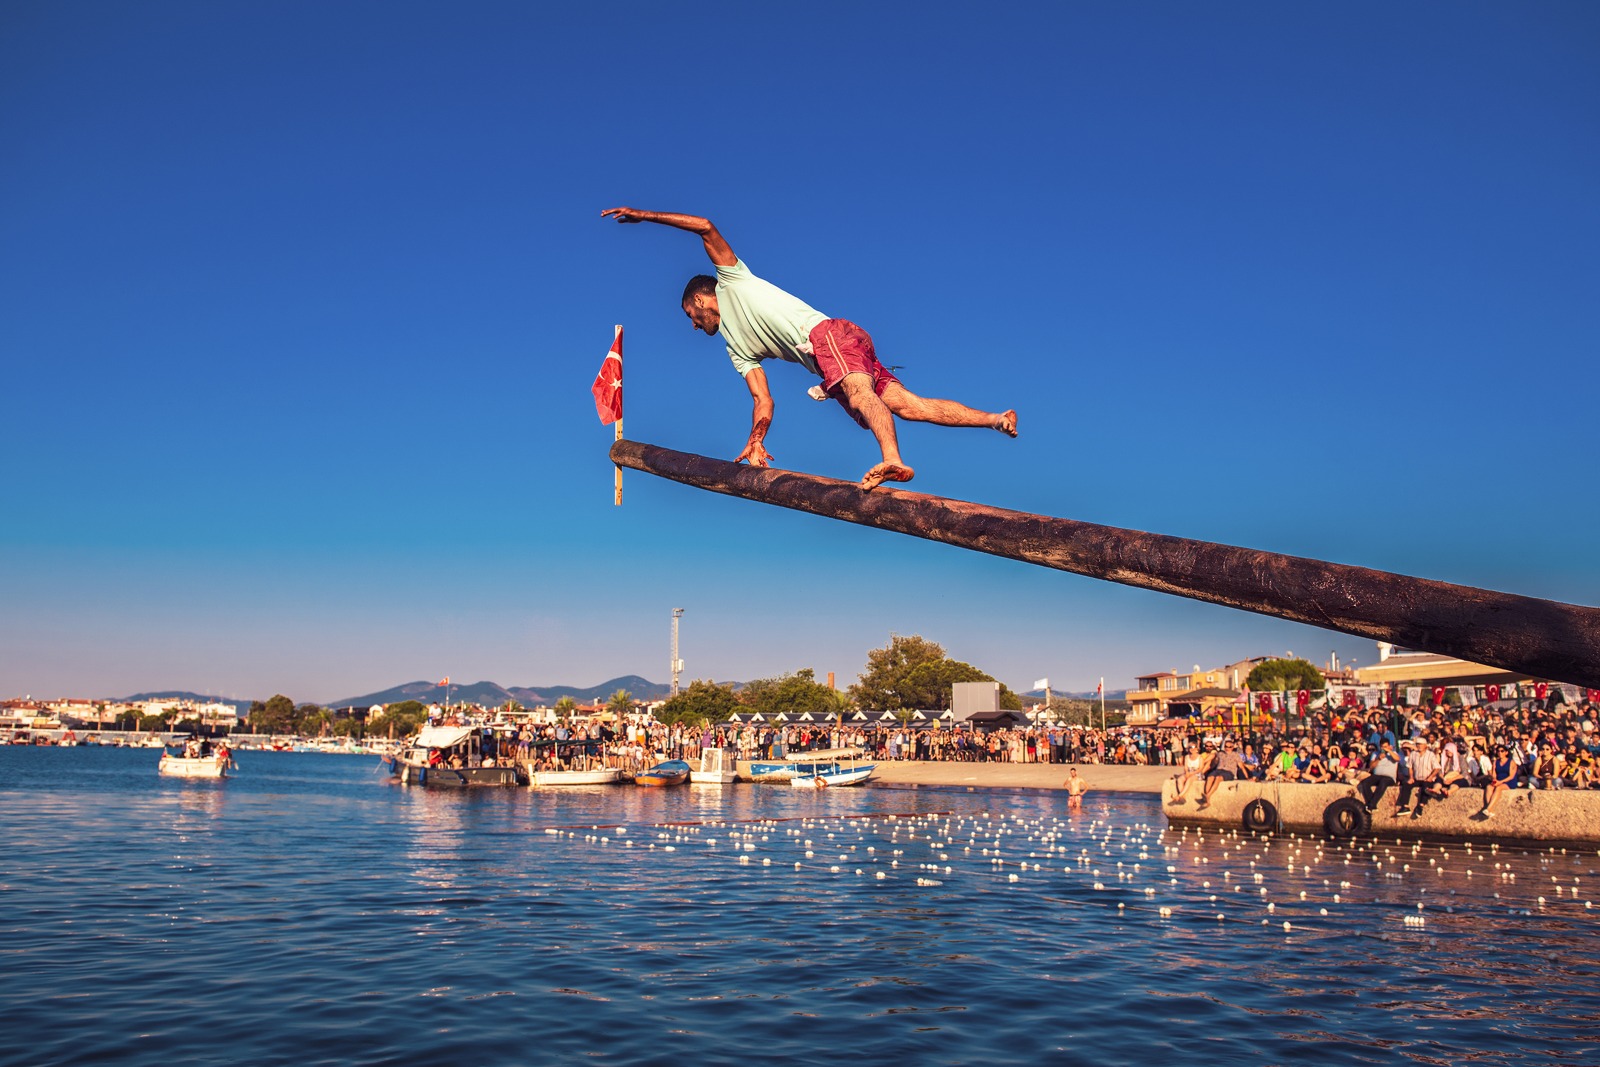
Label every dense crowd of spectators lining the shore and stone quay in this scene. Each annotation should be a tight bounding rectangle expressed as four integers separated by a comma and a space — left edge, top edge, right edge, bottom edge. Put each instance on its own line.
457, 699, 1600, 816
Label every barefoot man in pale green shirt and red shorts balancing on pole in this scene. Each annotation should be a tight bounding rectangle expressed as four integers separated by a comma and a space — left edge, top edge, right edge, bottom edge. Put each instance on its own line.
600, 208, 1016, 490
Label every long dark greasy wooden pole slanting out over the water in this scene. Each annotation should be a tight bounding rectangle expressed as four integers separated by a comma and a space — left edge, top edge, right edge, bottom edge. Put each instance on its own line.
611, 442, 1600, 688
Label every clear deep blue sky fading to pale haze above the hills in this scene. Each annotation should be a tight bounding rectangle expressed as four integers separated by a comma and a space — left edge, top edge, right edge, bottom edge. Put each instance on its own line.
0, 0, 1600, 701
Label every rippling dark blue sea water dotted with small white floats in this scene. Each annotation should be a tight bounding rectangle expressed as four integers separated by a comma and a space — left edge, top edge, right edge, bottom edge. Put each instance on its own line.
0, 749, 1600, 1065
